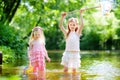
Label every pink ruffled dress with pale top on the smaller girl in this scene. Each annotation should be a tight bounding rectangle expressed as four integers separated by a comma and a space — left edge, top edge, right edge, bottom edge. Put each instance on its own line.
29, 40, 46, 72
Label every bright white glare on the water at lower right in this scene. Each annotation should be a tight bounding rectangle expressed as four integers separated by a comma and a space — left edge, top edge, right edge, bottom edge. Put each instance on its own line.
87, 61, 120, 80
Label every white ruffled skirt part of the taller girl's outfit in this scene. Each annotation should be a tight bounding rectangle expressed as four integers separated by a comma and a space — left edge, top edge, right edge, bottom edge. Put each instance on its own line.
61, 52, 81, 68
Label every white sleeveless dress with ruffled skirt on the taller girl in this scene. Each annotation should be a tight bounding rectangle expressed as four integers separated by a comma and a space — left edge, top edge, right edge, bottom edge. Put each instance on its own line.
61, 32, 81, 69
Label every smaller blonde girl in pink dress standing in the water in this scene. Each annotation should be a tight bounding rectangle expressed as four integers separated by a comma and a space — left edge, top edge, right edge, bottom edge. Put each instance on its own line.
28, 27, 50, 80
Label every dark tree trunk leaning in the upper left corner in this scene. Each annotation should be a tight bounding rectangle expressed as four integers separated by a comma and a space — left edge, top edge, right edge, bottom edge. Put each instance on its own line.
1, 0, 20, 24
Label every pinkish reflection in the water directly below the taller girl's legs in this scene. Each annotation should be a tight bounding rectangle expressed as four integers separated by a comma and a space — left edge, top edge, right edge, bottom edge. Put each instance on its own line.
60, 73, 81, 80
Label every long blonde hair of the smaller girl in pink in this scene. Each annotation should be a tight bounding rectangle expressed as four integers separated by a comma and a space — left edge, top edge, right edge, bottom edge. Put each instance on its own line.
29, 26, 45, 45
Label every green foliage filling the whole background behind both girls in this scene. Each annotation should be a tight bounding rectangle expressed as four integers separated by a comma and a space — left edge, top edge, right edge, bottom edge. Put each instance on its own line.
0, 0, 120, 63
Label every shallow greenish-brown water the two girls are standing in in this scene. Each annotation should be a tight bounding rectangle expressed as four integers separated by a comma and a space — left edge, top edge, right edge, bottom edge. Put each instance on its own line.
0, 51, 120, 80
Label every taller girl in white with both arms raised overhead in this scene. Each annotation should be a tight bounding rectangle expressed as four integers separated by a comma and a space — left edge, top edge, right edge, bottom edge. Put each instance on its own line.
59, 9, 83, 73
